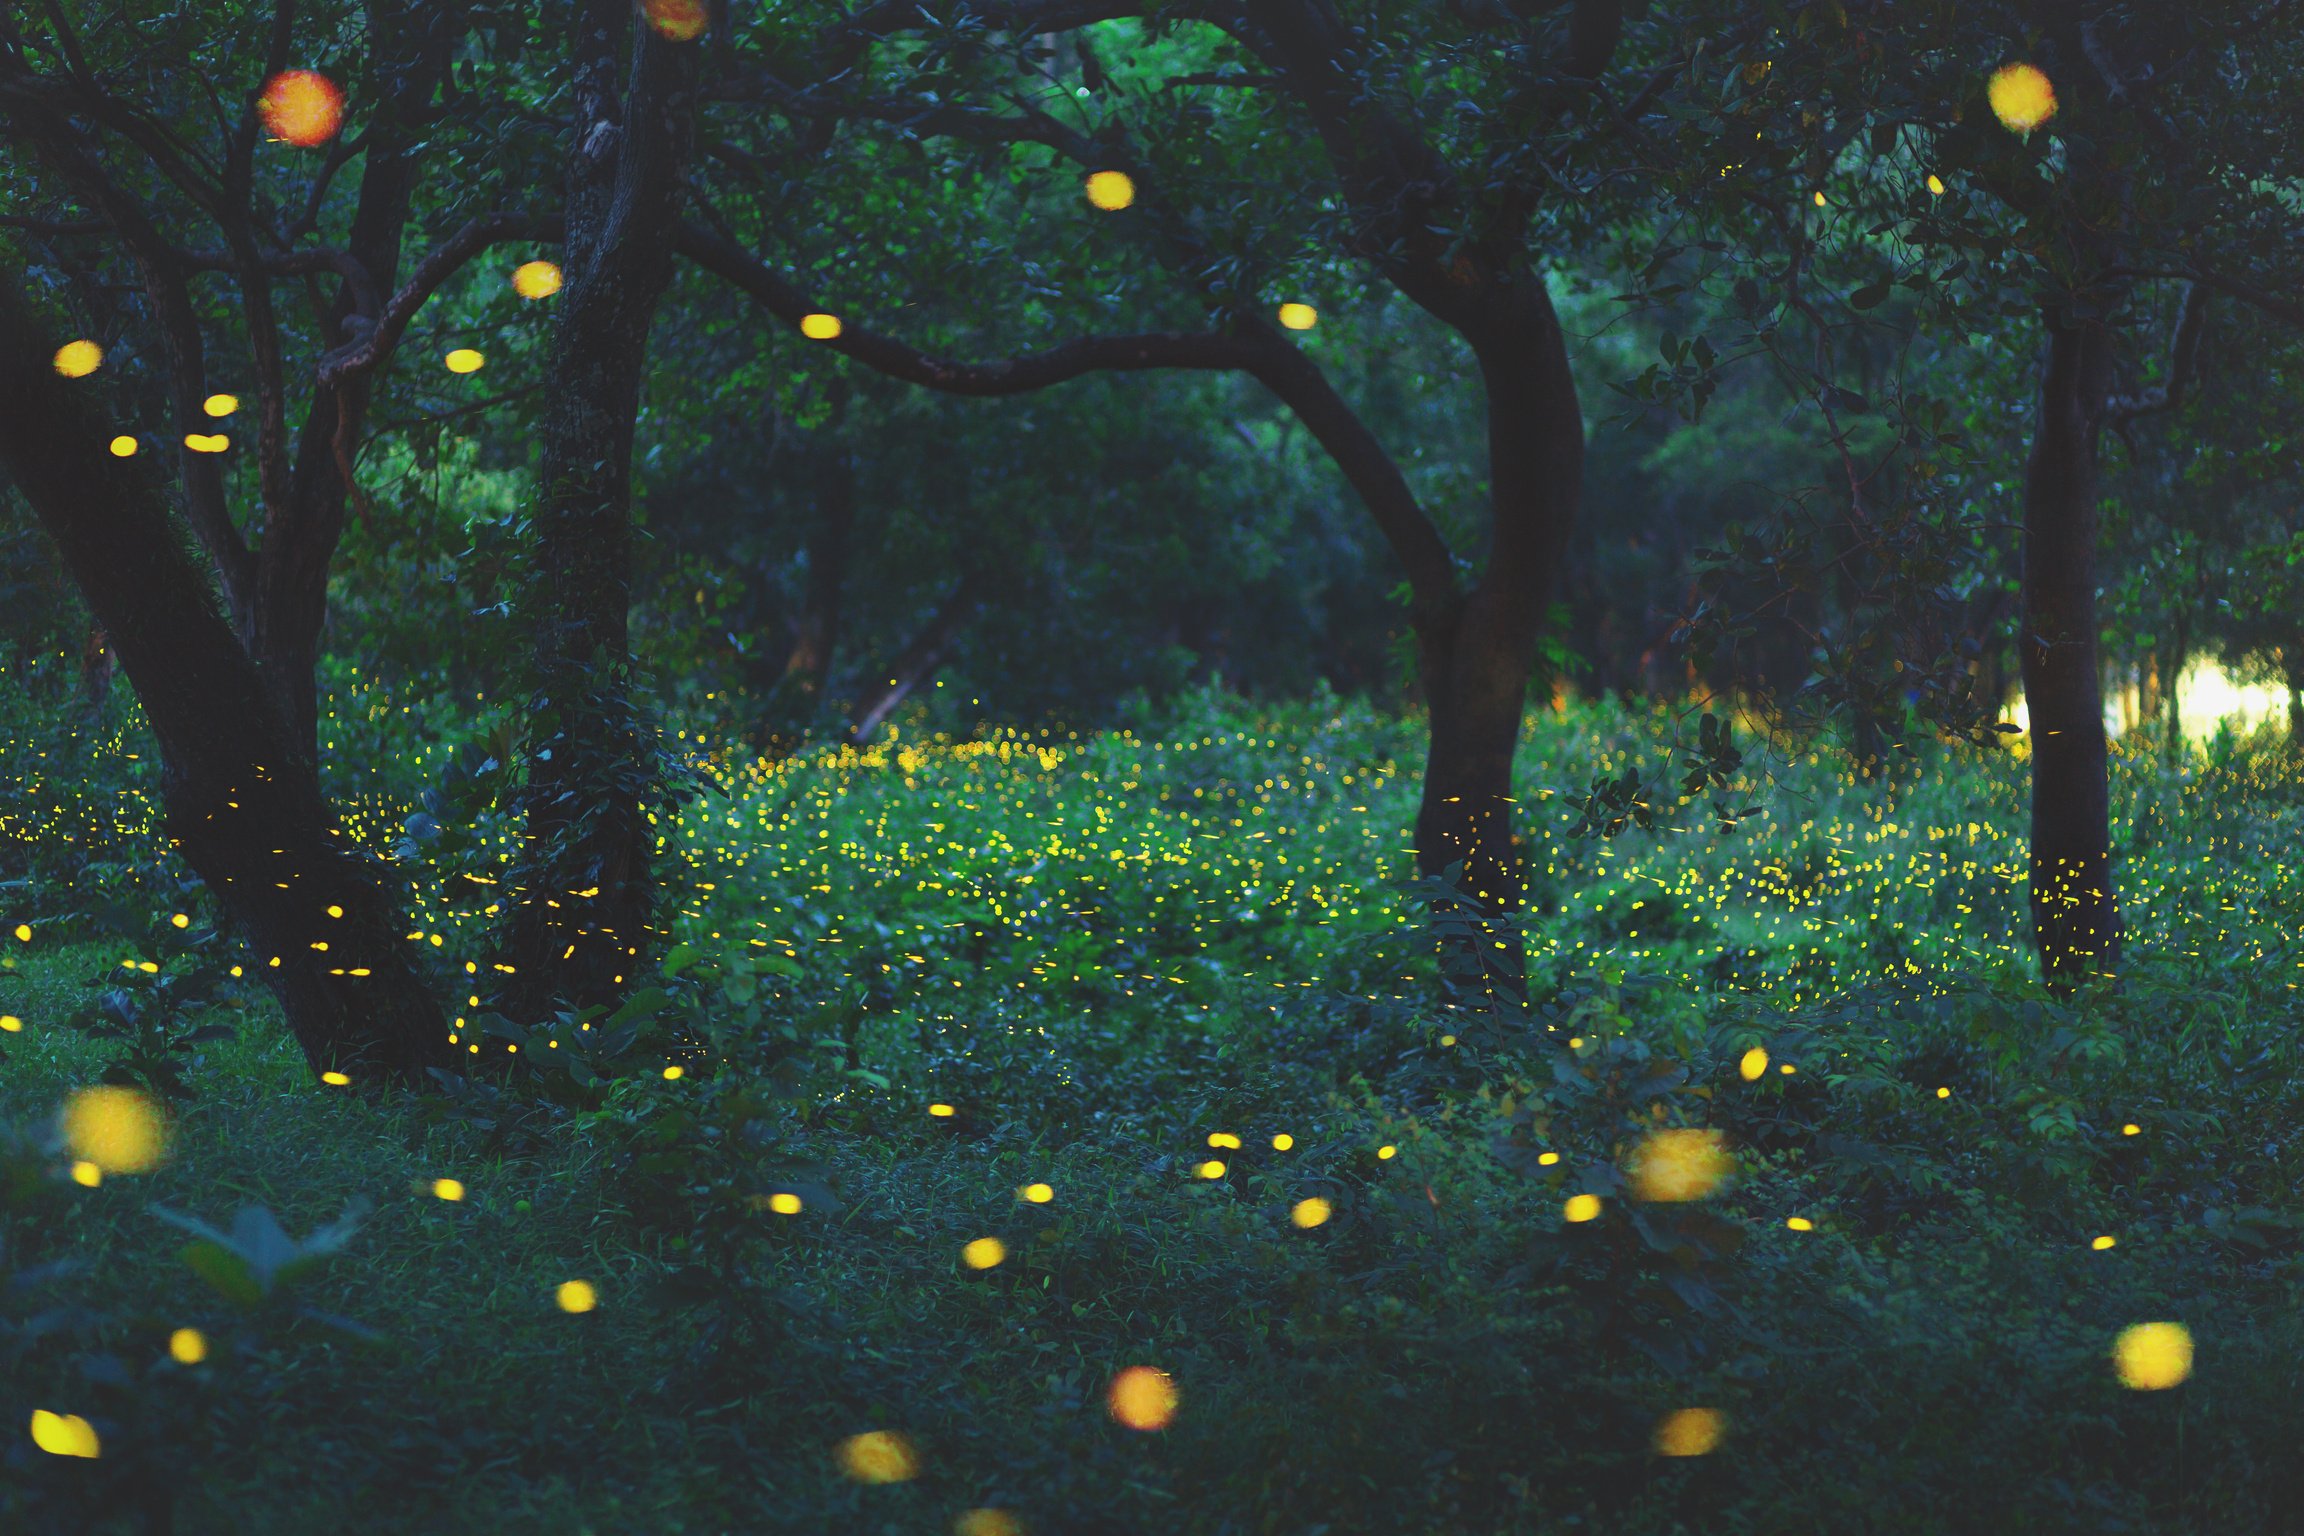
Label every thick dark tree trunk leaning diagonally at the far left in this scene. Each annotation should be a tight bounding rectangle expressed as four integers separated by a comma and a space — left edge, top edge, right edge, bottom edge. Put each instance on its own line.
0, 282, 452, 1080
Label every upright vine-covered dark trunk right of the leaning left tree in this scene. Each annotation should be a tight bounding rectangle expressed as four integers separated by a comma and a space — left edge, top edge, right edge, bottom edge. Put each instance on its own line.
507, 0, 696, 1018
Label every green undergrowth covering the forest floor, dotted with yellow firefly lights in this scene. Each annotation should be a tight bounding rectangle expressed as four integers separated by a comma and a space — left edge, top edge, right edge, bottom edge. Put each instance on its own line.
0, 702, 2304, 1536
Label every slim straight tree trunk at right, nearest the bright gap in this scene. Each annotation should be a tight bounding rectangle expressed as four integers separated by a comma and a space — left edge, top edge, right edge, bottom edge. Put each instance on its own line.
2018, 313, 2119, 993
